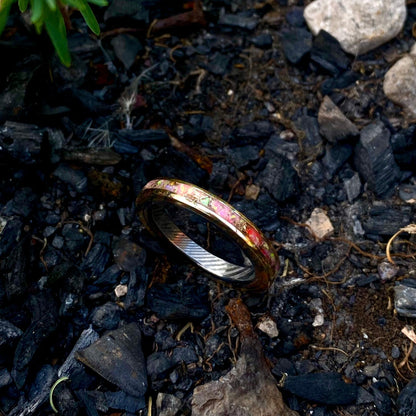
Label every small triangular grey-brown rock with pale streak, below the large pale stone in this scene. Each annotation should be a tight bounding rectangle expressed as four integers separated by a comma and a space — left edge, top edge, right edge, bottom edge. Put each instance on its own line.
318, 95, 359, 143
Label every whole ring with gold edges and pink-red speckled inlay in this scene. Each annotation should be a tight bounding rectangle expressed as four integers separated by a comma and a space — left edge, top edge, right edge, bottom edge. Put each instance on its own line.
136, 178, 279, 291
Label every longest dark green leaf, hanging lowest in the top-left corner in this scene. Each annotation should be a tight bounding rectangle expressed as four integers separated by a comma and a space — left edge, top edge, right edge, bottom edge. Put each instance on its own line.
45, 8, 71, 66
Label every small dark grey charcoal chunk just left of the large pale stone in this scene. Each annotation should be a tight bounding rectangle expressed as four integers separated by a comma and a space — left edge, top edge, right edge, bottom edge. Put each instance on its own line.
280, 27, 312, 64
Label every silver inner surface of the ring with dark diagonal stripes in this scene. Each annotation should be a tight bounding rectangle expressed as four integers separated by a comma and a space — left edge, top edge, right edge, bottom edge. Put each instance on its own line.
150, 205, 255, 283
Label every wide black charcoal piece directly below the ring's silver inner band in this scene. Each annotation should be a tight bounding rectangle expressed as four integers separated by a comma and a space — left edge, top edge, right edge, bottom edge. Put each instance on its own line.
147, 282, 210, 319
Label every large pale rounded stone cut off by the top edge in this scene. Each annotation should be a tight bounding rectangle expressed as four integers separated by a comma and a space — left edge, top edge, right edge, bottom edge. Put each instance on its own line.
304, 0, 406, 55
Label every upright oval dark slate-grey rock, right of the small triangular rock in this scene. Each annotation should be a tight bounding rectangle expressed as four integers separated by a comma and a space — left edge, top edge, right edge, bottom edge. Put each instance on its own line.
355, 121, 401, 198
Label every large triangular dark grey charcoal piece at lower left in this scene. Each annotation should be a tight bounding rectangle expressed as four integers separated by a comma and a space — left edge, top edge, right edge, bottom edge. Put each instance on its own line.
75, 323, 147, 399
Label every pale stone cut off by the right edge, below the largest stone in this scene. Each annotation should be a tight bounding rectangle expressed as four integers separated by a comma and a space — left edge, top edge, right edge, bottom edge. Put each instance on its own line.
383, 44, 416, 117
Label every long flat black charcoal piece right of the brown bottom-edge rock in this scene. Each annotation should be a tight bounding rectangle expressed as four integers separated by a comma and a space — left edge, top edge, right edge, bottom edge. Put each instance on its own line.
283, 373, 358, 405
